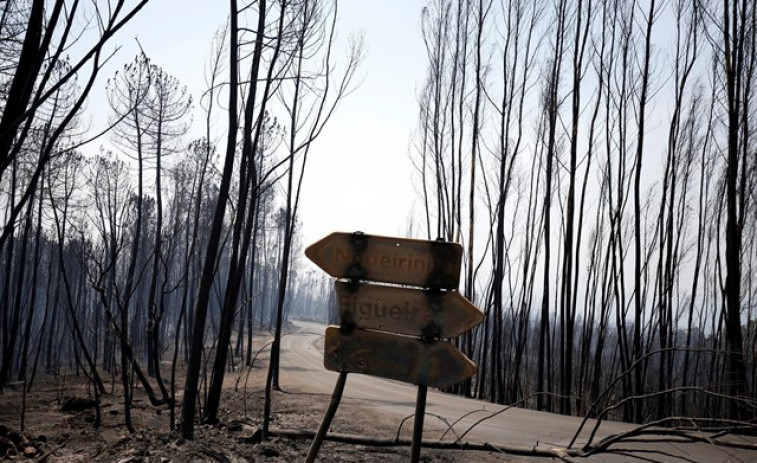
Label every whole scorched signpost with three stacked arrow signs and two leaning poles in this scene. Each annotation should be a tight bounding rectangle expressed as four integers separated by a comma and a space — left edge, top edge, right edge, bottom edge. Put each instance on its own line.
305, 232, 484, 463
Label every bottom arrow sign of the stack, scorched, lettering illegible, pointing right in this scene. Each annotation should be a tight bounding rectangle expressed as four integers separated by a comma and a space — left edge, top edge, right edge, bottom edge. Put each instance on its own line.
323, 326, 476, 388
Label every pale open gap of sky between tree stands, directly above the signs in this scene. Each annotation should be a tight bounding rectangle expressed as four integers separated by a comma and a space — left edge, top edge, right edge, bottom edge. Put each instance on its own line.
301, 0, 426, 246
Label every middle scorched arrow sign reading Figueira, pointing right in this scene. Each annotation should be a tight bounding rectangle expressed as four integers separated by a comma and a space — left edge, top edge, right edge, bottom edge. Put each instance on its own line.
336, 281, 484, 338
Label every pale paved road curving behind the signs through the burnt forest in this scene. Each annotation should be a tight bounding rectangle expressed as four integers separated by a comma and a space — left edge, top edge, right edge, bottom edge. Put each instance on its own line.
281, 322, 757, 463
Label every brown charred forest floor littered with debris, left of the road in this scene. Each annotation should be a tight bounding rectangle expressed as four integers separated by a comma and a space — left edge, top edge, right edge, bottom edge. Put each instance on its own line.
0, 356, 528, 463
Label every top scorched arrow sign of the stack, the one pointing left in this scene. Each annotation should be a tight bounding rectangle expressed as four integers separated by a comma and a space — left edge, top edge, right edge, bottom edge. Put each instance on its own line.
305, 232, 463, 289
